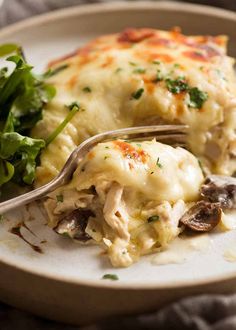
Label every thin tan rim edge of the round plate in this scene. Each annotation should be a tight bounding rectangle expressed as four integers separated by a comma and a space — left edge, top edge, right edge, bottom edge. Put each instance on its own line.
0, 1, 236, 290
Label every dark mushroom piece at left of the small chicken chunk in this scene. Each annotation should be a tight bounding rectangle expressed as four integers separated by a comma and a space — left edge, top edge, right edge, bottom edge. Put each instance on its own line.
54, 208, 94, 242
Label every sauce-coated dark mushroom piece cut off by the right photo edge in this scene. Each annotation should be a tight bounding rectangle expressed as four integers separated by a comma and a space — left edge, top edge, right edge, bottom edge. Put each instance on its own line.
201, 175, 236, 209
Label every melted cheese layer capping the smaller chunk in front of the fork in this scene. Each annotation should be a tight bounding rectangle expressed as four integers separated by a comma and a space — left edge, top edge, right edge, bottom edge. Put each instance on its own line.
71, 140, 203, 202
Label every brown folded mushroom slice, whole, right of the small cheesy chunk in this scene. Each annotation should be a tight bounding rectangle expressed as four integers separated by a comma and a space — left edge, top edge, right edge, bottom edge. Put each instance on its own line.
180, 201, 222, 232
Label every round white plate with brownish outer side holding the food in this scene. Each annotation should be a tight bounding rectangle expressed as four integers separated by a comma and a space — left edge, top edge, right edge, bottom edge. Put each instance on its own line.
0, 2, 236, 323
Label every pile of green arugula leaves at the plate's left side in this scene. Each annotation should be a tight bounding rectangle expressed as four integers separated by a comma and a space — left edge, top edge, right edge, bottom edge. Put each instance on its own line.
0, 44, 56, 186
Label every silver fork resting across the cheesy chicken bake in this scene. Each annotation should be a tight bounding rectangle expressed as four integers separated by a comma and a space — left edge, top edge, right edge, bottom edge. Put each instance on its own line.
0, 125, 188, 214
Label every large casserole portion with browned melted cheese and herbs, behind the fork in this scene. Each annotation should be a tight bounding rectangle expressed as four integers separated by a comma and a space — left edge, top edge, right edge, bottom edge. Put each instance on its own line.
33, 29, 236, 185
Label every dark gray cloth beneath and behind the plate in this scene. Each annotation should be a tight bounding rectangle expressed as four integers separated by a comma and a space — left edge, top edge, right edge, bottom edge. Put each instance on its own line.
0, 0, 236, 330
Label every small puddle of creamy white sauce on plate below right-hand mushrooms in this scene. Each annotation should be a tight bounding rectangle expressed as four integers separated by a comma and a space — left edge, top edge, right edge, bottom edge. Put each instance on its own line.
151, 234, 211, 265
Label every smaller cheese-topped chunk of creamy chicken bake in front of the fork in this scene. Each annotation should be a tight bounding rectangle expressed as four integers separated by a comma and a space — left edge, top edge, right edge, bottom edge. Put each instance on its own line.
45, 140, 203, 267
